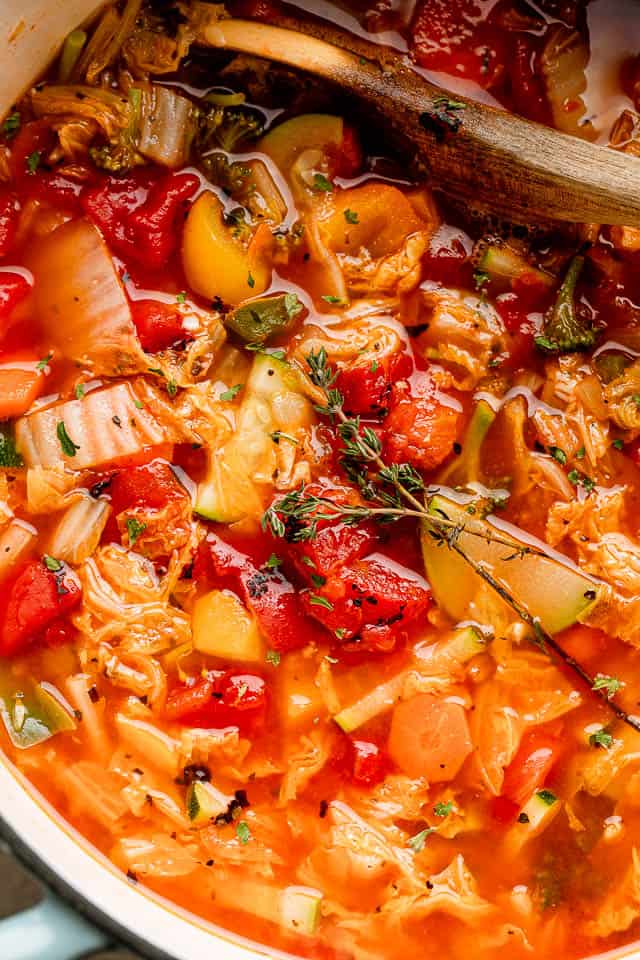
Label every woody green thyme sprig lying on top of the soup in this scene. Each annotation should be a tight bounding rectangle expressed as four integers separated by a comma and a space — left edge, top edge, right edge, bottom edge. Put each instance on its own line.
262, 347, 640, 732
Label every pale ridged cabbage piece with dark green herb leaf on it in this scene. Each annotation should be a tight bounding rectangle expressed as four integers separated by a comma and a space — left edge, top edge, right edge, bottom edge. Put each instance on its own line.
16, 383, 170, 470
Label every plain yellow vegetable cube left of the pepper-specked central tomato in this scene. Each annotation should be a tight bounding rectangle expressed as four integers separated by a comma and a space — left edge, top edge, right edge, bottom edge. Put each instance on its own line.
193, 590, 265, 663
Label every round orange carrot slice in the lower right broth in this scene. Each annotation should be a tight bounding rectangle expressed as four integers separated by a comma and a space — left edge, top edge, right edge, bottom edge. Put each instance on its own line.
388, 693, 473, 783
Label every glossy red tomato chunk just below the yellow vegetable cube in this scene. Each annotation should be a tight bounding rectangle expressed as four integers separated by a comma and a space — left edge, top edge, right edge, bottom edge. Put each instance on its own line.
165, 670, 267, 733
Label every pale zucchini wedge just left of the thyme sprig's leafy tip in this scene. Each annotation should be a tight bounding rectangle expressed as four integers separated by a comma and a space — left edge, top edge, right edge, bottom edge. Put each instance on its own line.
195, 354, 311, 523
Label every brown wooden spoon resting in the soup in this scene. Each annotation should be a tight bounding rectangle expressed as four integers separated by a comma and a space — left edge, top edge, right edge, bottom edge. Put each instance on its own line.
197, 8, 640, 227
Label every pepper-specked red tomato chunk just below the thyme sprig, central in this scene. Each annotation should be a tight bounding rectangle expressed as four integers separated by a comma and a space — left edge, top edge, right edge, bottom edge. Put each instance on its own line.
301, 557, 431, 653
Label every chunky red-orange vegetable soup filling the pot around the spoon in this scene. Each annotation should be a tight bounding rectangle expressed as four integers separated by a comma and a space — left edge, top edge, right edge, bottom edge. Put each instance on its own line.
0, 0, 640, 960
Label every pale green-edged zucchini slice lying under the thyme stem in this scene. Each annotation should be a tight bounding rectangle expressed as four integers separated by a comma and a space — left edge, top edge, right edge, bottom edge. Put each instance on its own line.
422, 497, 600, 634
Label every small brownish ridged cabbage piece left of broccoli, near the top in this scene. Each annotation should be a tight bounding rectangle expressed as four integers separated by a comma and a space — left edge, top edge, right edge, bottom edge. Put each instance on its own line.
138, 83, 196, 167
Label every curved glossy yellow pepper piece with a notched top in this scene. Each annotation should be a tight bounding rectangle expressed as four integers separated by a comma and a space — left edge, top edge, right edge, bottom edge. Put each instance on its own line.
182, 191, 272, 304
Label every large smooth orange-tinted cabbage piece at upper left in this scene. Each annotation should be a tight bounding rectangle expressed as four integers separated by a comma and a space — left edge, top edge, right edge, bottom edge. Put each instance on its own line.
27, 220, 146, 376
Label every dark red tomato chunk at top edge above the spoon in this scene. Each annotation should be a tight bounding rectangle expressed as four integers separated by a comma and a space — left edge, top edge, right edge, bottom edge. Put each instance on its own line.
411, 0, 506, 89
